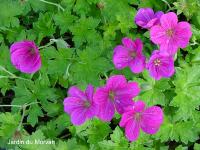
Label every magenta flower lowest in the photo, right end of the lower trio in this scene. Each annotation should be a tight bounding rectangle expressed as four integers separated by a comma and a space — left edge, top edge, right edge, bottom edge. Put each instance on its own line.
119, 100, 163, 141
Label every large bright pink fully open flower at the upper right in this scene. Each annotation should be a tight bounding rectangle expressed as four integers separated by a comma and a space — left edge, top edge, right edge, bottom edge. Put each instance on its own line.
150, 12, 192, 55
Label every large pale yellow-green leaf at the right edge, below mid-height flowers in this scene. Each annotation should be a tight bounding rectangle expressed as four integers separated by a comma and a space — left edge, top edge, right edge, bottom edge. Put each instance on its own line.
170, 65, 200, 120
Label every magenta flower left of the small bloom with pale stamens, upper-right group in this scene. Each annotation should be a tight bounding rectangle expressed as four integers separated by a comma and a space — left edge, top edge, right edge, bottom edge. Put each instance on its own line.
113, 38, 145, 73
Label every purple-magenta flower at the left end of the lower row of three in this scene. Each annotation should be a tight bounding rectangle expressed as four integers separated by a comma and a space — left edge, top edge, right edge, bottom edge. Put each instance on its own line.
63, 85, 98, 125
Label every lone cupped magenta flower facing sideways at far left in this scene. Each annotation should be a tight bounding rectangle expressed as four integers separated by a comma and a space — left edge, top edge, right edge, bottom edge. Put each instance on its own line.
10, 41, 41, 73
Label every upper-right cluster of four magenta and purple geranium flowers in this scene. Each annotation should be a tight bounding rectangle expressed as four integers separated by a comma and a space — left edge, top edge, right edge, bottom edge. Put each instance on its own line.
113, 8, 192, 80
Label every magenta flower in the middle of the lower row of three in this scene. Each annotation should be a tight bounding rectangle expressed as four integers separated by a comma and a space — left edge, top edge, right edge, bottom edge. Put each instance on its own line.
94, 75, 140, 121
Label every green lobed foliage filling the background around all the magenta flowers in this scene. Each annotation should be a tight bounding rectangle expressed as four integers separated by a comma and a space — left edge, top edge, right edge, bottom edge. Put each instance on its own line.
0, 0, 200, 150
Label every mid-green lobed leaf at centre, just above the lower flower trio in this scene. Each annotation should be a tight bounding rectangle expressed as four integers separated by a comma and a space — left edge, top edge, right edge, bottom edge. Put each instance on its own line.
72, 48, 111, 85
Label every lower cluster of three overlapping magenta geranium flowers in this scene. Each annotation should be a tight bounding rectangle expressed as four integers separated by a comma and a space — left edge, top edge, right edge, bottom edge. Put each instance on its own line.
63, 75, 163, 141
